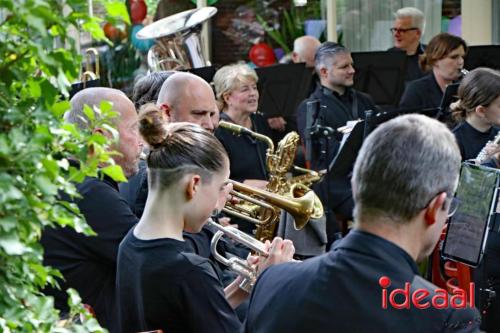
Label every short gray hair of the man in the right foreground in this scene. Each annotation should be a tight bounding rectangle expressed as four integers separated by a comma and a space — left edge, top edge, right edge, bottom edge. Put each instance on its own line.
351, 115, 461, 223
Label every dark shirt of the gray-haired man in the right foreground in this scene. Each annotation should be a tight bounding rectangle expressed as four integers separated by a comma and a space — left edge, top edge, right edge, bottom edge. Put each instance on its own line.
245, 230, 479, 333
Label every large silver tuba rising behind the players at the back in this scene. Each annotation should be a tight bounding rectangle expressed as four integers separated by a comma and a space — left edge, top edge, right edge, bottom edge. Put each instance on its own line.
136, 7, 217, 72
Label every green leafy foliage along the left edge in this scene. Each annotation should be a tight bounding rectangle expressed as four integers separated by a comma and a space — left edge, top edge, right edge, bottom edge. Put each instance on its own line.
0, 0, 128, 332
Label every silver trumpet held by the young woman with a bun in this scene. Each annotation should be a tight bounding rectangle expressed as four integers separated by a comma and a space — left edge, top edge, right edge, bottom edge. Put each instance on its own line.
208, 219, 268, 292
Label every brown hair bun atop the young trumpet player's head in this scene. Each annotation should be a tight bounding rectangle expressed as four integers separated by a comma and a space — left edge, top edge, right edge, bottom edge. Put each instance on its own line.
139, 103, 167, 148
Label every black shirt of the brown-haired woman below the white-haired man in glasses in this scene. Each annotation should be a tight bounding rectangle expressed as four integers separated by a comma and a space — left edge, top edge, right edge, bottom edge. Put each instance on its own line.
399, 72, 443, 109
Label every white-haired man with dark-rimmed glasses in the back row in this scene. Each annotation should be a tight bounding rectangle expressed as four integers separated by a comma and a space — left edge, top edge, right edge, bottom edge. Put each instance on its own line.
389, 7, 425, 81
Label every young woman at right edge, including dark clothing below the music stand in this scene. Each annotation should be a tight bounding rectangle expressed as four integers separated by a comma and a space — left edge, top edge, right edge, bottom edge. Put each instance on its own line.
452, 68, 500, 332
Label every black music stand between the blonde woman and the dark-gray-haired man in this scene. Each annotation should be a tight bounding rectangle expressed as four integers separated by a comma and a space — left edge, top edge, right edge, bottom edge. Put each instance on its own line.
255, 63, 312, 118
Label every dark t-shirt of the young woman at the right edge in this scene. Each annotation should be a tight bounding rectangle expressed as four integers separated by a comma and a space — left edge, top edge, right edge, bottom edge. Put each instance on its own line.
453, 121, 498, 161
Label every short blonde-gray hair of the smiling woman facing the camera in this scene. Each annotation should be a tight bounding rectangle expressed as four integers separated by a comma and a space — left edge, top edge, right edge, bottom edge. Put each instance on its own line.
214, 63, 259, 111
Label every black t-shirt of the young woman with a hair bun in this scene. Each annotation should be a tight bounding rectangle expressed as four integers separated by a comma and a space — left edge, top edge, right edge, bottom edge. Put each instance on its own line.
116, 229, 241, 333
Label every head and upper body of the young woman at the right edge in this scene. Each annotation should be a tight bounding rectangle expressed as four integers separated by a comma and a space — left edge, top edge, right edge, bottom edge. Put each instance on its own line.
451, 68, 500, 160
